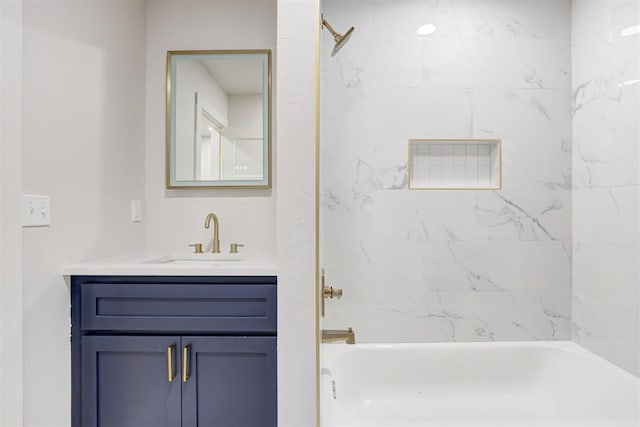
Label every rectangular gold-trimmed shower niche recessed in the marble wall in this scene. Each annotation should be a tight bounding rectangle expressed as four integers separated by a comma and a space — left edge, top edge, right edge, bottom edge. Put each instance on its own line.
409, 139, 502, 190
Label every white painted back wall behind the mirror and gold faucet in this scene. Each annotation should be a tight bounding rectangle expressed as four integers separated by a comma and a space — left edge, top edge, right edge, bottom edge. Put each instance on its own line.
145, 0, 277, 252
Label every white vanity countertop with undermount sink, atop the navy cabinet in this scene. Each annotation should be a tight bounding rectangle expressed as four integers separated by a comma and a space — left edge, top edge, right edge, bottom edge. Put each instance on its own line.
62, 249, 277, 276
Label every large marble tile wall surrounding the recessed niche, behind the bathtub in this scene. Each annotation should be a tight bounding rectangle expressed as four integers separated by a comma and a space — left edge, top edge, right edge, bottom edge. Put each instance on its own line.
320, 0, 572, 342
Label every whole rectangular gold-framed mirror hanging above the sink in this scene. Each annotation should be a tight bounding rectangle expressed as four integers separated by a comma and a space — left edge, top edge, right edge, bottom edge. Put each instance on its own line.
167, 50, 271, 188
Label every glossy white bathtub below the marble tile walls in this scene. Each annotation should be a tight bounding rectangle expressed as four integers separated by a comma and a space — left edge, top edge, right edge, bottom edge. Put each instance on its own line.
321, 342, 640, 427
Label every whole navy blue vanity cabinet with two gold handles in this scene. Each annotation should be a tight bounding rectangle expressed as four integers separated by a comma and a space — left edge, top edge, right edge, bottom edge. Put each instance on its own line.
71, 276, 277, 427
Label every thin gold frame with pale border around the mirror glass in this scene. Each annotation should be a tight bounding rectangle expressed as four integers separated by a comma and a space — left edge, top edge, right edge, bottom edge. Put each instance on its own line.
165, 49, 272, 190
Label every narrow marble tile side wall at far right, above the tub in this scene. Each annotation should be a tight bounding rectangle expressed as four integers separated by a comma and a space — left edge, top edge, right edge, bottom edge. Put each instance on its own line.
572, 0, 640, 375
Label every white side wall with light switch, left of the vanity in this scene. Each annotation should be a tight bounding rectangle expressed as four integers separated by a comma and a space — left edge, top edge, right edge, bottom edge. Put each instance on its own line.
22, 0, 145, 427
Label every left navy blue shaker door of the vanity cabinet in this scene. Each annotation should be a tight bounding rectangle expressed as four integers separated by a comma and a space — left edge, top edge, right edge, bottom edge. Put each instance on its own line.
82, 336, 181, 427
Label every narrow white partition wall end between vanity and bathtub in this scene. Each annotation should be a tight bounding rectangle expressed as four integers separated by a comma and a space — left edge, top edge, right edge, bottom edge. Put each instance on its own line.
276, 0, 319, 427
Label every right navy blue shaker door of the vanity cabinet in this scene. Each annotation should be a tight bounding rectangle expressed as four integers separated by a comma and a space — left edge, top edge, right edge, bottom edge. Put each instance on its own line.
182, 336, 277, 427
